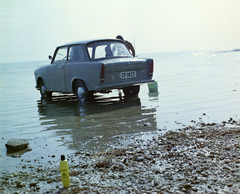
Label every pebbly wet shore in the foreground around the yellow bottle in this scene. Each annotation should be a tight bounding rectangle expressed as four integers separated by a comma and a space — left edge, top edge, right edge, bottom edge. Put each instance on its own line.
0, 118, 240, 194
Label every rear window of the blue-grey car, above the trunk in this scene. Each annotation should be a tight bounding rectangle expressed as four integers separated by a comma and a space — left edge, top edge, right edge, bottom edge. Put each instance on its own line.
87, 41, 132, 59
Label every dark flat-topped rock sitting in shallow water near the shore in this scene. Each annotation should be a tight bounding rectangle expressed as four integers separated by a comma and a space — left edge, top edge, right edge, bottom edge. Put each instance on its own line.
5, 139, 29, 153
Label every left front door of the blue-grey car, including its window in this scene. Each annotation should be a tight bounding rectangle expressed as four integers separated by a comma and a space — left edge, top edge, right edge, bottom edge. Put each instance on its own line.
47, 46, 68, 92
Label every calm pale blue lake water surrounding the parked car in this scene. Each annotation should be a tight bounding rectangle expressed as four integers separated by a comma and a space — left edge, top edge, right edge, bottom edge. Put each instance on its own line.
0, 52, 240, 171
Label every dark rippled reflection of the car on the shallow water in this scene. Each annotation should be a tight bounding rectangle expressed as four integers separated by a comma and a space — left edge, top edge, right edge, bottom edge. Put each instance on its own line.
38, 95, 157, 150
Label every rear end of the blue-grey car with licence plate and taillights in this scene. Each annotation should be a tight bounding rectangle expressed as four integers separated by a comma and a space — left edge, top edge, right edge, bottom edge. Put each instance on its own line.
94, 58, 153, 89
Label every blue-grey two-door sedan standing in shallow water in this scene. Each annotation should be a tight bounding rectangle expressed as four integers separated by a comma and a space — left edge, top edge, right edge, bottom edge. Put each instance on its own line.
34, 39, 153, 102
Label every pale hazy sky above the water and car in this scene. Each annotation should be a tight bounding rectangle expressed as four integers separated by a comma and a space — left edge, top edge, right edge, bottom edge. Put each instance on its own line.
0, 0, 240, 63
